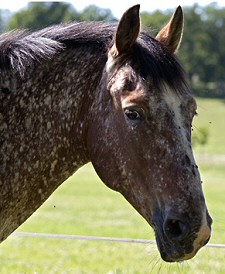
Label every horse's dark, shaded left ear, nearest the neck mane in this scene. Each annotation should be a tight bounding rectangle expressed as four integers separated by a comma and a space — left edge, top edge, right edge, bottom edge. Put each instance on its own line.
113, 5, 140, 56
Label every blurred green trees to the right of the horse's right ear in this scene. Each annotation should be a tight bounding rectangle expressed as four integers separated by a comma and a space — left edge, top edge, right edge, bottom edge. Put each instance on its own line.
179, 3, 225, 97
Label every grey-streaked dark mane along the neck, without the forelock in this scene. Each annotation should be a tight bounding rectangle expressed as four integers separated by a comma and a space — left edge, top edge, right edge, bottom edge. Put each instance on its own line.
0, 22, 112, 76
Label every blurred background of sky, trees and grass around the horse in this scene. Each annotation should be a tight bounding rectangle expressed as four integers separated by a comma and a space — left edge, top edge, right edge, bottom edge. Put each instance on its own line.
0, 0, 225, 274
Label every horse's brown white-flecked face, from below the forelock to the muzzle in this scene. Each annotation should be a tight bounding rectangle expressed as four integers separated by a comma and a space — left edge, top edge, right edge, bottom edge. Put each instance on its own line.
89, 4, 211, 262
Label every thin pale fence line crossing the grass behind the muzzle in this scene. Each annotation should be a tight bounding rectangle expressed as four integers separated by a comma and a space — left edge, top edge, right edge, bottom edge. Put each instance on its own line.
12, 232, 225, 249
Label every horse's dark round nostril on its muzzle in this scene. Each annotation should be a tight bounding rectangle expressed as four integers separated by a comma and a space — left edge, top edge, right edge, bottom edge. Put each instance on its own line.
163, 219, 190, 240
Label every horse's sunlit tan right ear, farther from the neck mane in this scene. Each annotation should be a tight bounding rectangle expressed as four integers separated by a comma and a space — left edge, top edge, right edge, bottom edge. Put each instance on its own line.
156, 6, 184, 53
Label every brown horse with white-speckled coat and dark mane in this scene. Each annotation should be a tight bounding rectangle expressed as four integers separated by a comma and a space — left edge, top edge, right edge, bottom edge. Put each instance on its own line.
0, 5, 212, 262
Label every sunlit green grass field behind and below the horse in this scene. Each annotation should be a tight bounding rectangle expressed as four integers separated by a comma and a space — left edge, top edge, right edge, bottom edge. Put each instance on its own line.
0, 99, 225, 274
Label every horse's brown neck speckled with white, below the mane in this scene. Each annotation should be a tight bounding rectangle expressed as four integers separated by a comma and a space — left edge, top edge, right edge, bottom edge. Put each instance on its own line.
0, 49, 105, 242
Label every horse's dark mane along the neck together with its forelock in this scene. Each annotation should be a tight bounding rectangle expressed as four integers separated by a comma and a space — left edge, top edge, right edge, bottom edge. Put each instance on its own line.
0, 22, 187, 91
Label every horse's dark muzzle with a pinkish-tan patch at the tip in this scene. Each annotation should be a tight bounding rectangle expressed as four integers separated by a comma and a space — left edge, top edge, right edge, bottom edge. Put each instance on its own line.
153, 211, 212, 262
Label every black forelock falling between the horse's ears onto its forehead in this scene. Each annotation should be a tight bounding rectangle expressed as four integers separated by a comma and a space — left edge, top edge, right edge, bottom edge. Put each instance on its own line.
131, 33, 189, 93
